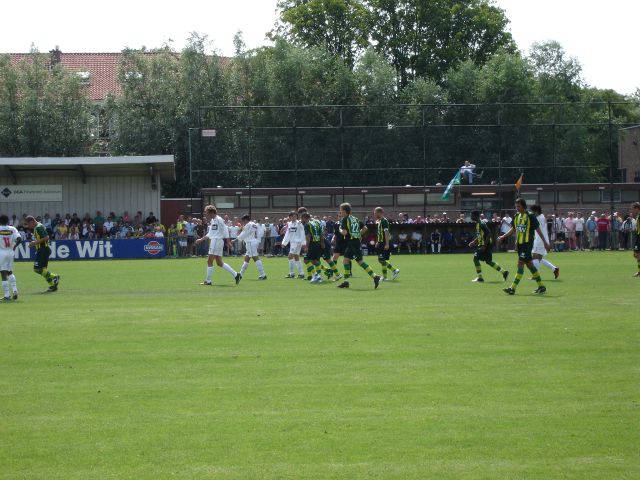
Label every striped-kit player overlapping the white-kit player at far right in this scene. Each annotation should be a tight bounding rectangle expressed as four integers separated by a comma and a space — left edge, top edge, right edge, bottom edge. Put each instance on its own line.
498, 198, 551, 295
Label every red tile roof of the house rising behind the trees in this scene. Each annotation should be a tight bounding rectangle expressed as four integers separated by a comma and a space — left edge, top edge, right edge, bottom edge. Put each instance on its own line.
9, 53, 122, 102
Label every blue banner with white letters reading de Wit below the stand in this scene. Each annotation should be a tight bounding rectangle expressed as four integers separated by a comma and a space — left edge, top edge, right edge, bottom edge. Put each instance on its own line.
15, 238, 166, 260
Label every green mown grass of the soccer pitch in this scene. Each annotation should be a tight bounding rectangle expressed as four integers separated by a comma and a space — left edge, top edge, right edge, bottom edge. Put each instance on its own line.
0, 252, 640, 480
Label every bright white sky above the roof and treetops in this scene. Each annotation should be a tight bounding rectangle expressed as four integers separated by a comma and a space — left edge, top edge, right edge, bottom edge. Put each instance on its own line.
0, 0, 640, 94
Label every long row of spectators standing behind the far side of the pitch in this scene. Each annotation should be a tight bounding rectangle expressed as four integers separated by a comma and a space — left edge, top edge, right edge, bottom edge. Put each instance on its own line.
9, 211, 636, 257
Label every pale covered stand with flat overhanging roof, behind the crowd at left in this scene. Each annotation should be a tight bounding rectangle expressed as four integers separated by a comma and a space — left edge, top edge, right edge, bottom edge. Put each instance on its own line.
0, 155, 175, 221
